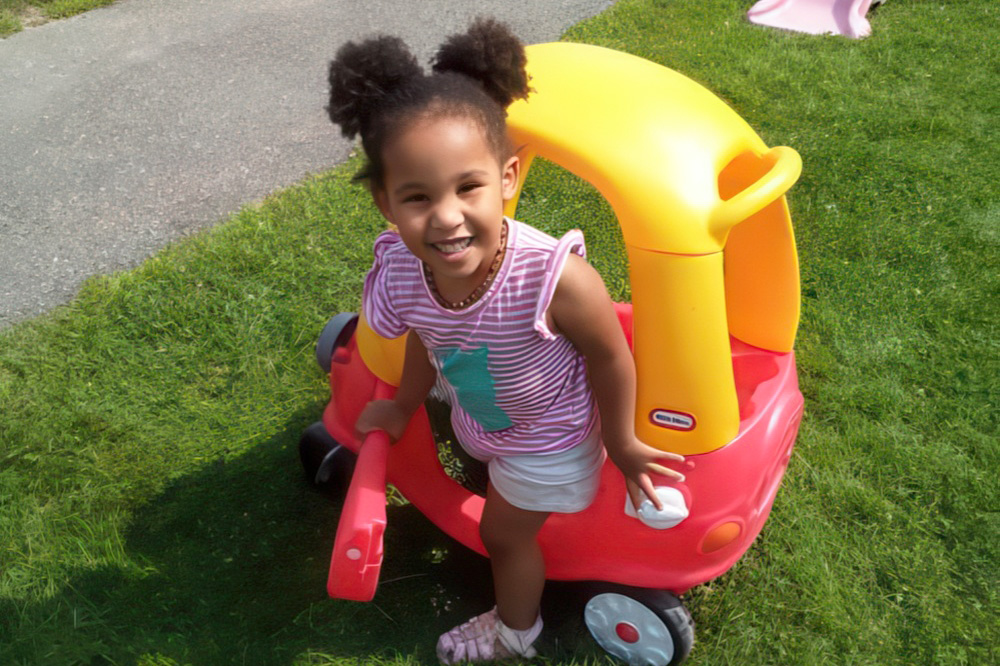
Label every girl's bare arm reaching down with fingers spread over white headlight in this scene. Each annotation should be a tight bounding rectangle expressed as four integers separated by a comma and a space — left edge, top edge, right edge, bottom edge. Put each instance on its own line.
548, 254, 684, 509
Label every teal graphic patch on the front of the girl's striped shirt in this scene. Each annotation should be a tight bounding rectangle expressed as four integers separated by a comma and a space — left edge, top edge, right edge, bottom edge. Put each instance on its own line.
434, 347, 514, 432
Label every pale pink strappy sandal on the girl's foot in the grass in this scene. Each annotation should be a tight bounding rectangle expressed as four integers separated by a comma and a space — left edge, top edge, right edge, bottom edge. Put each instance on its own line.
437, 606, 542, 664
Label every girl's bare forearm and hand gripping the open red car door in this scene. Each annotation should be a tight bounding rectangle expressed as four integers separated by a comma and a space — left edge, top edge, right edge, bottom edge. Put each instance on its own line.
354, 331, 437, 441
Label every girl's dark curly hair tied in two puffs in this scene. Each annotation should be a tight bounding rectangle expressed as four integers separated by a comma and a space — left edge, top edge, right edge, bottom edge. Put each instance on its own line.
327, 18, 530, 188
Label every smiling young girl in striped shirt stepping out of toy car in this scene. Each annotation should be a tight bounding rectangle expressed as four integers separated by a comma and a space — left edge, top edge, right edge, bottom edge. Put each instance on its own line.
328, 20, 682, 664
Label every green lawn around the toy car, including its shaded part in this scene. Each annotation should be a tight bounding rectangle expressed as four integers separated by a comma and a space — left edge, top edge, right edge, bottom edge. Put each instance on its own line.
0, 0, 1000, 666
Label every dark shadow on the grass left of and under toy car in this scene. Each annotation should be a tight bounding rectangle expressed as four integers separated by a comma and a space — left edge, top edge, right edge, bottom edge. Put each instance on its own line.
0, 412, 600, 665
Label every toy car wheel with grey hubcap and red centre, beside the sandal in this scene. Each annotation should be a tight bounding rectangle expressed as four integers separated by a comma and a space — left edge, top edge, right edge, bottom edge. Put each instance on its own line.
584, 584, 694, 666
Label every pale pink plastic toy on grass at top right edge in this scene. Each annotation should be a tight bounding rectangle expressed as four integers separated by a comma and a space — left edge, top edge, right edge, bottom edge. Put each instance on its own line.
747, 0, 878, 39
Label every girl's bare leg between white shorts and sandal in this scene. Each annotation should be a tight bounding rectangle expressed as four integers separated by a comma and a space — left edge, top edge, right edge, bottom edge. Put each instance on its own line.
479, 486, 549, 630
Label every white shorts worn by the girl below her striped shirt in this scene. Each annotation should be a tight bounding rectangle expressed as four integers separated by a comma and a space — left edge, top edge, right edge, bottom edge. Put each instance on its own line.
488, 425, 606, 513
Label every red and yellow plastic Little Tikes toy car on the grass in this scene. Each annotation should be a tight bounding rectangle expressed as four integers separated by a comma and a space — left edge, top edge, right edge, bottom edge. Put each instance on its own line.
300, 43, 803, 664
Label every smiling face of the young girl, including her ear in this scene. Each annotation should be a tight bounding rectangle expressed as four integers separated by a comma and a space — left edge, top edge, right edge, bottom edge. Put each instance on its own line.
374, 116, 520, 301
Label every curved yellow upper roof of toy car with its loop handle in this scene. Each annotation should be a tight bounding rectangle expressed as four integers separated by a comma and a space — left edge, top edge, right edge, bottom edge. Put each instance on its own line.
508, 42, 800, 254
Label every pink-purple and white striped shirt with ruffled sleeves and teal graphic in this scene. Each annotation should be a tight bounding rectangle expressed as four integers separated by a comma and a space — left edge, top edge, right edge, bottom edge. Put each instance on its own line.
363, 218, 597, 460
